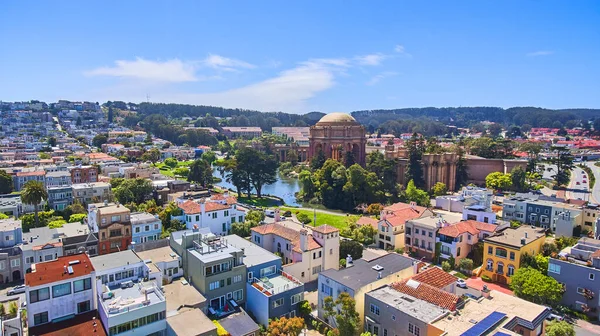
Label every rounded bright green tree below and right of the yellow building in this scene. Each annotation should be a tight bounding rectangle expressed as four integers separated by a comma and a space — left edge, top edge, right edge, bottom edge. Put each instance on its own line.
510, 267, 562, 306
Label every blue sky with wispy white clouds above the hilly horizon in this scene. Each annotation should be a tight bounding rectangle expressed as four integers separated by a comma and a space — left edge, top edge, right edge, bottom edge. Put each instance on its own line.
0, 0, 600, 113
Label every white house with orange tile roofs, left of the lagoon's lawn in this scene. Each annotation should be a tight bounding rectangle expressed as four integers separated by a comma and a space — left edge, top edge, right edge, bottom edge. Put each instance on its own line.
179, 194, 246, 235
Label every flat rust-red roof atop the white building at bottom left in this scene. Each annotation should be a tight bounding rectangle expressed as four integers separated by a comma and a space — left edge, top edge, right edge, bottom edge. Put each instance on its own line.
25, 253, 94, 287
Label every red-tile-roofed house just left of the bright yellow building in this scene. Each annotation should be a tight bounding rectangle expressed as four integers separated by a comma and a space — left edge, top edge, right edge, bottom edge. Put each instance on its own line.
436, 220, 498, 264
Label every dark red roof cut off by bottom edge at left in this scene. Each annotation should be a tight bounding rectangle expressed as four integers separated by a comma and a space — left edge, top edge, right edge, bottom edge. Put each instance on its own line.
29, 310, 107, 336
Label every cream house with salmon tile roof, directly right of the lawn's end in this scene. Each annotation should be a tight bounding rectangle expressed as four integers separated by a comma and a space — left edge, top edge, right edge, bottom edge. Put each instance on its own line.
375, 202, 433, 249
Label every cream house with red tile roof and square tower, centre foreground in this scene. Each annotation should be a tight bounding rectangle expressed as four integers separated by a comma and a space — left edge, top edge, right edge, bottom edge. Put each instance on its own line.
251, 222, 340, 283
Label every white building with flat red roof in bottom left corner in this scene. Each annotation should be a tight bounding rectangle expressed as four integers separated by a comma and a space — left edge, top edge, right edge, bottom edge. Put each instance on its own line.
25, 254, 96, 327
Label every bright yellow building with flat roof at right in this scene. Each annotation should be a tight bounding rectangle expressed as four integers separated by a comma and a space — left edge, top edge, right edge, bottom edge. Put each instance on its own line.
481, 225, 546, 284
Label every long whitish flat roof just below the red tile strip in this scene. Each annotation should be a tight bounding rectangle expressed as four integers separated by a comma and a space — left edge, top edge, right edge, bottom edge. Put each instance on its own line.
367, 286, 447, 323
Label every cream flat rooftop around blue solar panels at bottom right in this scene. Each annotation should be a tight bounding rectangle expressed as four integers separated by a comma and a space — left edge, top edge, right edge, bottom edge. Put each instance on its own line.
433, 290, 550, 336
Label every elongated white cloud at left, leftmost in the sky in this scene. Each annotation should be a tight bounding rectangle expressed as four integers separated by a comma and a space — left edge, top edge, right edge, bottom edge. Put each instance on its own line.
84, 57, 198, 83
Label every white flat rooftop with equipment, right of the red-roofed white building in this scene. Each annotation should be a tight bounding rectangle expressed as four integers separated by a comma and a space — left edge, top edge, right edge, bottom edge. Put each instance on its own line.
98, 281, 165, 315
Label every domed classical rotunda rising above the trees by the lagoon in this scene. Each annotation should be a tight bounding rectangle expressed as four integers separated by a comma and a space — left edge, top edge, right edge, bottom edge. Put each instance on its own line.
308, 112, 367, 166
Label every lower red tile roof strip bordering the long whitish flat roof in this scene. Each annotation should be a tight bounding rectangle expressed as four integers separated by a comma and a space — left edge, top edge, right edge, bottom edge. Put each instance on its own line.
390, 279, 460, 311
